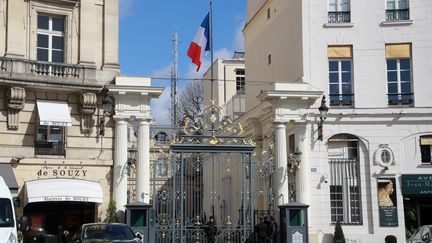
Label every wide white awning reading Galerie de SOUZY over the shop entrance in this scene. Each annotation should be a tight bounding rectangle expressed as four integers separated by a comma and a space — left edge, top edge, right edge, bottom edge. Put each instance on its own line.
25, 179, 103, 203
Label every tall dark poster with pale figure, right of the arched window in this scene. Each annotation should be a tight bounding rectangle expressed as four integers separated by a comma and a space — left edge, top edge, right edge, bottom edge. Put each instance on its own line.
377, 178, 398, 227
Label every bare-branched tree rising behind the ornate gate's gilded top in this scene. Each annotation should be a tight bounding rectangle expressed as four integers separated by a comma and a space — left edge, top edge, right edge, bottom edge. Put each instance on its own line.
177, 81, 204, 125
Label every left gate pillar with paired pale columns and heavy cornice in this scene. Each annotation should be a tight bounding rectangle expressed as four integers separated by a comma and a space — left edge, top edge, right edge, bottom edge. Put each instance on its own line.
108, 77, 164, 222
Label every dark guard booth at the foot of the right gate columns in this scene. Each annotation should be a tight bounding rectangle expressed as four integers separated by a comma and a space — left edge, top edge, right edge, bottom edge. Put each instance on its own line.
279, 202, 309, 243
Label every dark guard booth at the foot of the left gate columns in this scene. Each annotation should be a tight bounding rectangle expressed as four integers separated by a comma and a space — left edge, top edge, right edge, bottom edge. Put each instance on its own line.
126, 202, 151, 243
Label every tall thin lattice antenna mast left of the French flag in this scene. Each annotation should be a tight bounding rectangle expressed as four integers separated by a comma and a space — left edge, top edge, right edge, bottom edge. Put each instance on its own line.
171, 32, 178, 127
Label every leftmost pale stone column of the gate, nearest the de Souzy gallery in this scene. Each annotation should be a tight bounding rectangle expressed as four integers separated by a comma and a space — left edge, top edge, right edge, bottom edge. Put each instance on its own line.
113, 118, 128, 218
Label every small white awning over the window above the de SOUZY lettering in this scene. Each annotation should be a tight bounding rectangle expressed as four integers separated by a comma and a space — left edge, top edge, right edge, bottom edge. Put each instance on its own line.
36, 100, 72, 127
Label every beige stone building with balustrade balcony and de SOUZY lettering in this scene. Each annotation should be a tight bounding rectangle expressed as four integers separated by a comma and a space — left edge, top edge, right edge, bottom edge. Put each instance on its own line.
0, 0, 119, 240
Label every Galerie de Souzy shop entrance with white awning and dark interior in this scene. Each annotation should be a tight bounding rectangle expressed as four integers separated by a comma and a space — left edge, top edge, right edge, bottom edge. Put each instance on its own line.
24, 179, 103, 243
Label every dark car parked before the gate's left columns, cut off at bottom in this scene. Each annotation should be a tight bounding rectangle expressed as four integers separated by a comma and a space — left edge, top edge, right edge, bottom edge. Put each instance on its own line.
71, 223, 142, 243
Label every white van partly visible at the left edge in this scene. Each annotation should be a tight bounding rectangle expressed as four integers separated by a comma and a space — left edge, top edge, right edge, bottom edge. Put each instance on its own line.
0, 176, 18, 243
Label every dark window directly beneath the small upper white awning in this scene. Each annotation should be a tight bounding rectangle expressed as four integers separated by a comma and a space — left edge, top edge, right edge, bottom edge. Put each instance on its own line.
35, 125, 65, 155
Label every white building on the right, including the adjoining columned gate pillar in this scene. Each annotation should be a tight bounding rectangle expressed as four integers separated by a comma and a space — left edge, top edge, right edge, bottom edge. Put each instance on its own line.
226, 0, 432, 242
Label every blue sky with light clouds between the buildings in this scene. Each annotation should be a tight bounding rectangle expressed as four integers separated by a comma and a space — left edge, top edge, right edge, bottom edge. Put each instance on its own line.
119, 0, 246, 125
